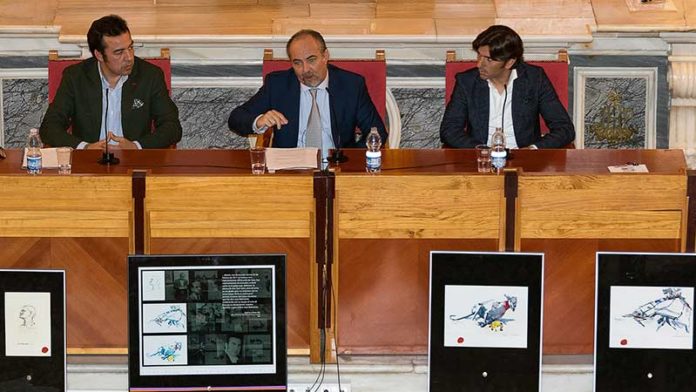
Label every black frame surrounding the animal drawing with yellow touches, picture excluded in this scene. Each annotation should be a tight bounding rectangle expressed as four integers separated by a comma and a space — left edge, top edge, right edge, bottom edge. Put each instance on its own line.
428, 252, 544, 392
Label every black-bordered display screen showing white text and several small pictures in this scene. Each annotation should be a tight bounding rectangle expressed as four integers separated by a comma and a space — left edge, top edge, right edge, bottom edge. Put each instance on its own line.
129, 255, 287, 392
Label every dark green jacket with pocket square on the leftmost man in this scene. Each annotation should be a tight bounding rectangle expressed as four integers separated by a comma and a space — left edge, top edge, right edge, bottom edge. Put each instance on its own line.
40, 57, 181, 148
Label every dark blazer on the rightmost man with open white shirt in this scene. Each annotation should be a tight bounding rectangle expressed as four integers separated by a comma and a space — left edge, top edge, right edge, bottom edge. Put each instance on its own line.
440, 63, 575, 148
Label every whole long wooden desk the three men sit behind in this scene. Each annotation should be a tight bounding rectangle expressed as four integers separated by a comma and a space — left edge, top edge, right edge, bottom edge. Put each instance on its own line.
0, 150, 696, 360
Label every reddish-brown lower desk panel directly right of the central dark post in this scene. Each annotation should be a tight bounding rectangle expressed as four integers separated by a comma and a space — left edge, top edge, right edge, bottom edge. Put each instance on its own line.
337, 239, 497, 354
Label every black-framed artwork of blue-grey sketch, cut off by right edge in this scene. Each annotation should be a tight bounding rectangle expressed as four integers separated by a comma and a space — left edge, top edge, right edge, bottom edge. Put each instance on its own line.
594, 252, 696, 392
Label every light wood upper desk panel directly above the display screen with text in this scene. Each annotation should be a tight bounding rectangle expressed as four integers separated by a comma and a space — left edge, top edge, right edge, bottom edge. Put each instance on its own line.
146, 176, 314, 238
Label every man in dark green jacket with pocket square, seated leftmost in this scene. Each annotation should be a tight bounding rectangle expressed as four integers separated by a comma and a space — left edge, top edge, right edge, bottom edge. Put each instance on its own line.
40, 15, 181, 149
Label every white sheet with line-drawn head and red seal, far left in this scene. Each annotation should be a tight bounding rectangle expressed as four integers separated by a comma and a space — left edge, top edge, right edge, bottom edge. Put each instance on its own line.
4, 292, 52, 357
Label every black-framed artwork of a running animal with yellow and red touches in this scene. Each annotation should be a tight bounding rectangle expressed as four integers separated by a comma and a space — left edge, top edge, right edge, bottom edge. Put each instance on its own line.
428, 252, 544, 392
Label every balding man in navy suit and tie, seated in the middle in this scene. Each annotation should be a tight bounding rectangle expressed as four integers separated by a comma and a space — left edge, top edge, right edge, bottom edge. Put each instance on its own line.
228, 30, 387, 150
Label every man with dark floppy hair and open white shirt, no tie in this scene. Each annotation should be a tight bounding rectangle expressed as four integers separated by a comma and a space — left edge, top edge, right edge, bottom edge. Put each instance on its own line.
440, 25, 575, 148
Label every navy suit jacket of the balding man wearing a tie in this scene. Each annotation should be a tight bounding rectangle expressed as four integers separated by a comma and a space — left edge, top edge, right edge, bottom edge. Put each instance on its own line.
228, 65, 387, 148
